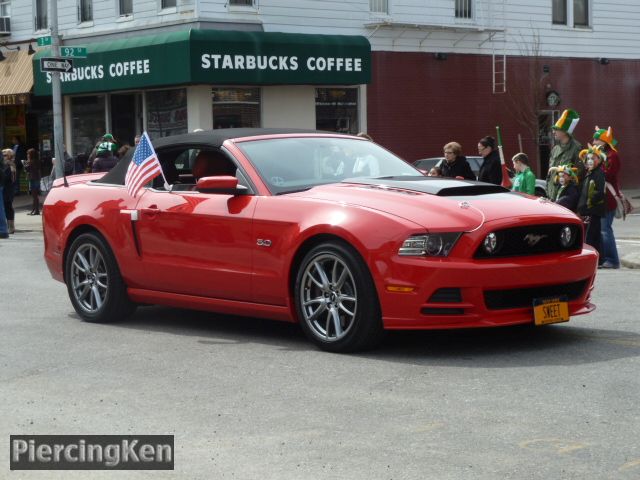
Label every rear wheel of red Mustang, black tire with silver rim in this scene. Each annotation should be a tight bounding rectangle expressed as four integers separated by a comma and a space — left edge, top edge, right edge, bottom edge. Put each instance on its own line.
65, 233, 136, 323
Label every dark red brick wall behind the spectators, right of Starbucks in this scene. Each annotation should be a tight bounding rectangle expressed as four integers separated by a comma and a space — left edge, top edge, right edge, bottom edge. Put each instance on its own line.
367, 52, 640, 188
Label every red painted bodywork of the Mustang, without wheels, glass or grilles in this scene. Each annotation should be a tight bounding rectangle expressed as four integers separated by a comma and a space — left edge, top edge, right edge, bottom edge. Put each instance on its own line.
43, 133, 598, 329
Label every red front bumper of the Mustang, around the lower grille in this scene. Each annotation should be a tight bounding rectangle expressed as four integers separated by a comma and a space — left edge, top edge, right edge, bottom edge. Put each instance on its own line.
378, 246, 598, 329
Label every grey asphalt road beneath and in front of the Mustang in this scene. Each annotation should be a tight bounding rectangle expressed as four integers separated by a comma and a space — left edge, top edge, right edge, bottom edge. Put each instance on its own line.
0, 210, 640, 480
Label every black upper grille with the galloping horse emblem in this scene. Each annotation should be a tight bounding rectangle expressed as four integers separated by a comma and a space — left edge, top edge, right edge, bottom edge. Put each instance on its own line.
474, 223, 582, 259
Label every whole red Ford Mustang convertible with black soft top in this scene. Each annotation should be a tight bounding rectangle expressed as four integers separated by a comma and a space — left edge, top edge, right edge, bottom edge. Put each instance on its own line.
43, 129, 597, 352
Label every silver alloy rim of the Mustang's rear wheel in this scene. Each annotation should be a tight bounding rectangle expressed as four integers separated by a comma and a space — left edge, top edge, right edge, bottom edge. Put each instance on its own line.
71, 244, 109, 313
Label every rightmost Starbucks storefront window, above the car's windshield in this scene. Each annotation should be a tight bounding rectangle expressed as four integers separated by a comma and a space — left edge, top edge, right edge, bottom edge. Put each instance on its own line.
316, 88, 358, 134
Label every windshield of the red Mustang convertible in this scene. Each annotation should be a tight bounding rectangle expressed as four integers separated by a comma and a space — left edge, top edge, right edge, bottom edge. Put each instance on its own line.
238, 137, 419, 194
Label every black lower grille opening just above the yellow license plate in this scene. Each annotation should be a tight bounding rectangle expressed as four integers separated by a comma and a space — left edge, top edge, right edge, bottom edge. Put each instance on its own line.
484, 280, 587, 310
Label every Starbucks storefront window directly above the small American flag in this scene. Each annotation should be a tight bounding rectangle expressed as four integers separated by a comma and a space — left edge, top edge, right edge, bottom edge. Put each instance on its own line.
146, 88, 187, 139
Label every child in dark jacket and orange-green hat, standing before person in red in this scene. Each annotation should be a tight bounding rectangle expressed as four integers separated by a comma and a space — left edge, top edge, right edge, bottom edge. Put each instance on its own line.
578, 145, 607, 256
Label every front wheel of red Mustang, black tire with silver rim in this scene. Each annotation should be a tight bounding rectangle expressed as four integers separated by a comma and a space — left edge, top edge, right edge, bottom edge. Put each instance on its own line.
294, 242, 384, 353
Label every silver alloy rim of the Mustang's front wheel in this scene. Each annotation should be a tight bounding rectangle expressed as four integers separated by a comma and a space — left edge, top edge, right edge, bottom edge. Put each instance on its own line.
300, 253, 358, 342
